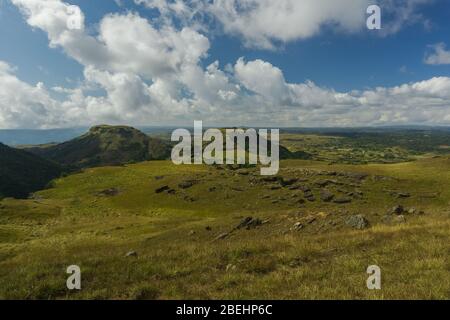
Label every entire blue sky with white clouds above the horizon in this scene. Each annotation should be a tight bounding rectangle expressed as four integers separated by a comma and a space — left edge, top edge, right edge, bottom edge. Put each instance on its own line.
0, 0, 450, 129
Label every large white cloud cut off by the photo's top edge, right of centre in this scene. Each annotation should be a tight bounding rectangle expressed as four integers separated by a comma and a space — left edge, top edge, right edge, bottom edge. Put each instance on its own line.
135, 0, 433, 49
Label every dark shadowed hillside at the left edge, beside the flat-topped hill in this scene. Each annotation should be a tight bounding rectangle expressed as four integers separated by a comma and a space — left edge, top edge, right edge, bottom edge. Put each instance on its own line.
0, 143, 61, 198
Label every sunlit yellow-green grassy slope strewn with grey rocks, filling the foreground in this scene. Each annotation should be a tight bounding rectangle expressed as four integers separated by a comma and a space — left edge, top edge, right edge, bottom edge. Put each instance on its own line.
0, 157, 450, 299
